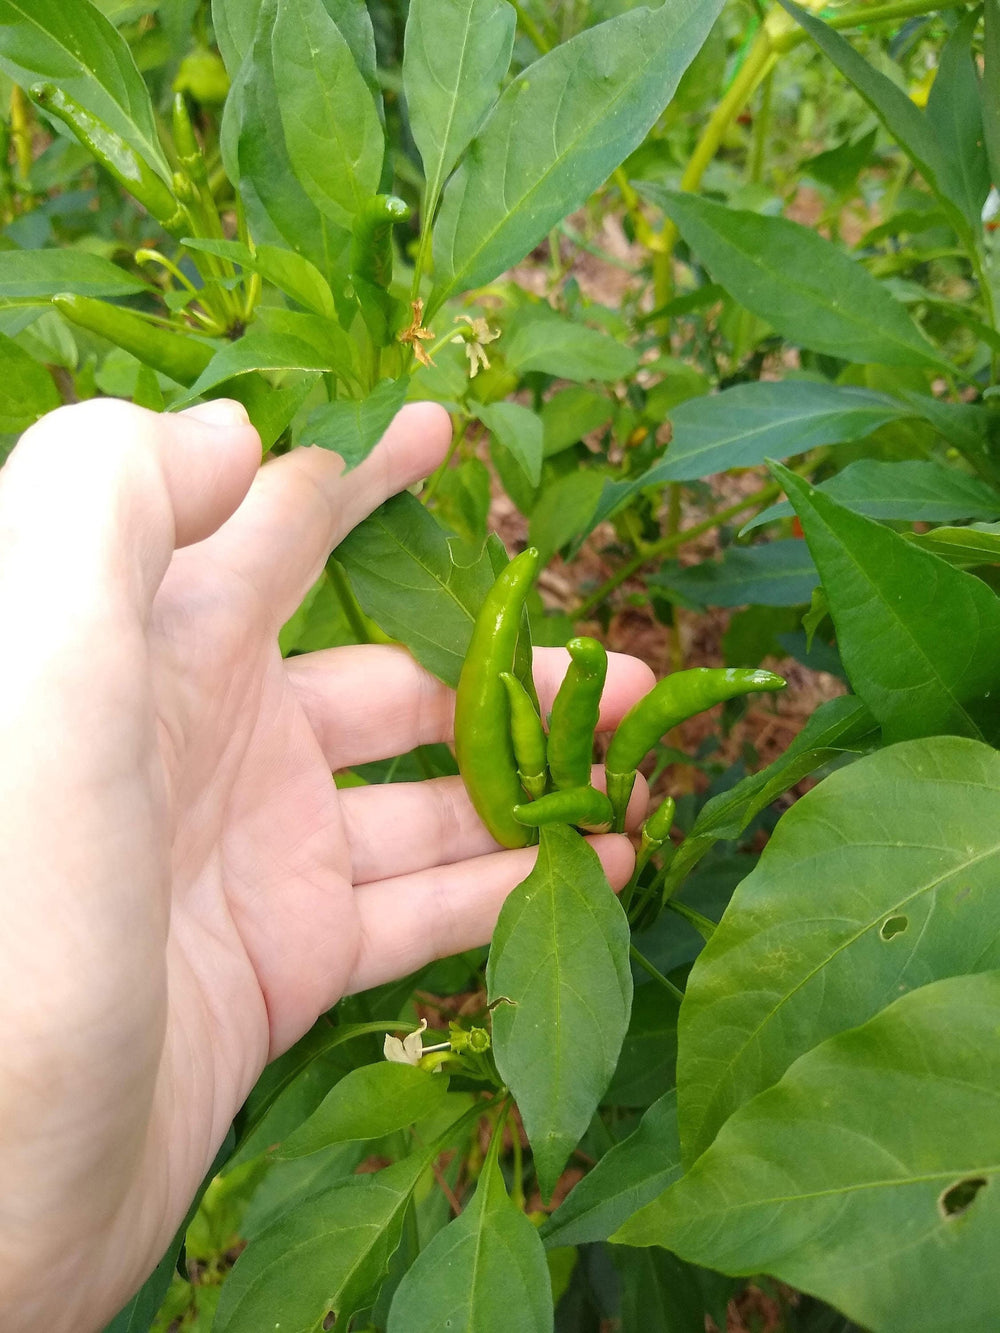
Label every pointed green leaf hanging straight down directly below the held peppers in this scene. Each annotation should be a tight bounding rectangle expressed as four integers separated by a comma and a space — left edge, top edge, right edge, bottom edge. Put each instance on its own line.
487, 824, 632, 1198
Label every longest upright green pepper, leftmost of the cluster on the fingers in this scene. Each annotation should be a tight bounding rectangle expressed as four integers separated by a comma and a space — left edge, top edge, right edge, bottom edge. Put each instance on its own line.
455, 548, 539, 846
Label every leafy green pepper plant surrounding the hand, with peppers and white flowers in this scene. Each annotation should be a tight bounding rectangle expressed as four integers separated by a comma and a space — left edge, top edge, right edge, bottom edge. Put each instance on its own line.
0, 0, 1000, 1333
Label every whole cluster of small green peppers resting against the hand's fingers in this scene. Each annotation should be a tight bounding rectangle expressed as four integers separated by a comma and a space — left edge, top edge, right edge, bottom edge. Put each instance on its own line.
455, 549, 785, 853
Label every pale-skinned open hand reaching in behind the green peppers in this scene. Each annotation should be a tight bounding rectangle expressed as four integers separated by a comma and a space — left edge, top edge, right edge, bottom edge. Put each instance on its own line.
0, 401, 653, 1333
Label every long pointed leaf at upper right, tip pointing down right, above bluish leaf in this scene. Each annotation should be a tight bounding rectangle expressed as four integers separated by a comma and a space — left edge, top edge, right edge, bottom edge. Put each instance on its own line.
639, 181, 947, 369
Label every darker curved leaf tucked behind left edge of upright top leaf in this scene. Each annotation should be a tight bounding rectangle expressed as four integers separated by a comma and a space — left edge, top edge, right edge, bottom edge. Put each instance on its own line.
220, 0, 351, 276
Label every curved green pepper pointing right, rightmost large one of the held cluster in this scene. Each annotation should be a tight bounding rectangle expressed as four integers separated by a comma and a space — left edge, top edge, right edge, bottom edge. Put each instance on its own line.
604, 667, 787, 833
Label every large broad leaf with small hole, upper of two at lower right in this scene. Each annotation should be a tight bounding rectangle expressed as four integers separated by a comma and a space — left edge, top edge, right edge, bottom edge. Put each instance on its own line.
677, 736, 1000, 1162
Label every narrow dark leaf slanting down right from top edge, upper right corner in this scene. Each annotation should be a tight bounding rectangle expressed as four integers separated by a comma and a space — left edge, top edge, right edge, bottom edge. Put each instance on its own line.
779, 0, 979, 235
